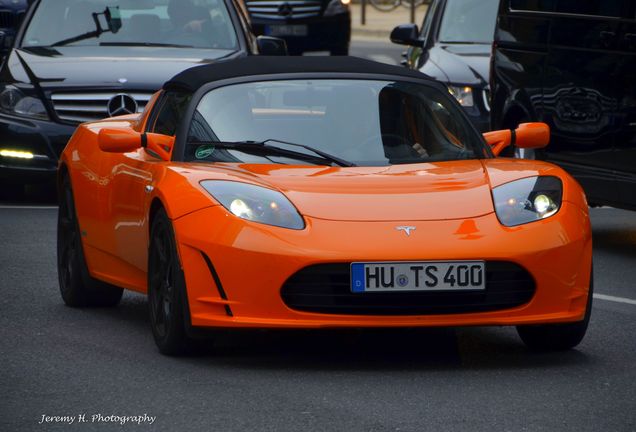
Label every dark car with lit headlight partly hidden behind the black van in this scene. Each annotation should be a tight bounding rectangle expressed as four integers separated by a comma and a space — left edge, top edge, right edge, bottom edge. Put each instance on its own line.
391, 0, 499, 132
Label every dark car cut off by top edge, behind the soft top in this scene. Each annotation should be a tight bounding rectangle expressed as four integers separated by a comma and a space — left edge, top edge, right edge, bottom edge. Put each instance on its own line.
245, 0, 351, 55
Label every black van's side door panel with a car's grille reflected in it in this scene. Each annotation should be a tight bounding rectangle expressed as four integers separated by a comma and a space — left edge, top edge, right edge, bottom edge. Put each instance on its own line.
543, 0, 629, 203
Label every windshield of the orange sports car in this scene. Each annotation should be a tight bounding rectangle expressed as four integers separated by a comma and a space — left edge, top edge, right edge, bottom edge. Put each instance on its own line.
185, 79, 490, 166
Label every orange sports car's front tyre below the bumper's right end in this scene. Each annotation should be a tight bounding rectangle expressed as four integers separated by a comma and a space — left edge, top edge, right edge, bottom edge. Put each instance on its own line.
517, 274, 594, 351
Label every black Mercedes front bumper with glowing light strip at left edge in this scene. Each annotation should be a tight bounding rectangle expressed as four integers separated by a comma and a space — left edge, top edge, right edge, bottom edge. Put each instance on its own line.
0, 115, 75, 184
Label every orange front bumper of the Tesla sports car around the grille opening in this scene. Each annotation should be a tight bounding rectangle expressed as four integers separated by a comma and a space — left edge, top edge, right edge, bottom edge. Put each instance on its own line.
174, 202, 592, 328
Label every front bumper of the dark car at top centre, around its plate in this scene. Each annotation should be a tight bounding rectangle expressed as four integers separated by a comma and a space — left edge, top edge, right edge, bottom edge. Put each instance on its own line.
252, 12, 351, 54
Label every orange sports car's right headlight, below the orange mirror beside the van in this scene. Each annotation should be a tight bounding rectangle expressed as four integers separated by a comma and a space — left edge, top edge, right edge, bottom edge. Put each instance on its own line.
492, 176, 563, 226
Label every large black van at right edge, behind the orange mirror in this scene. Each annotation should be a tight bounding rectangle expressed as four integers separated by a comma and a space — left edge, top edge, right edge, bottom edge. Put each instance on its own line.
491, 0, 636, 209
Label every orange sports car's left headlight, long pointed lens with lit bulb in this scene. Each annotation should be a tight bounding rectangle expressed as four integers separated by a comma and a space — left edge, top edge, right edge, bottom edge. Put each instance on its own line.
201, 180, 305, 230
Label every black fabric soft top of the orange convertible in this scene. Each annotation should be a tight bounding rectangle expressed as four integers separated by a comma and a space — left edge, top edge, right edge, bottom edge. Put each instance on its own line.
163, 56, 428, 92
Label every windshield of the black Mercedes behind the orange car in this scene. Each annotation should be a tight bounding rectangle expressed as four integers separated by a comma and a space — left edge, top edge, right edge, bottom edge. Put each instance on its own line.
22, 0, 238, 50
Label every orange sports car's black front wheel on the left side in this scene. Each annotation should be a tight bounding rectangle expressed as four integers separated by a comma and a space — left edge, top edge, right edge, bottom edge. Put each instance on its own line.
148, 209, 191, 355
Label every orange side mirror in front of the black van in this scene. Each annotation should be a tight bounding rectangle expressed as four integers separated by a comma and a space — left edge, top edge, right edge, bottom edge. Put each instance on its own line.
484, 123, 550, 156
